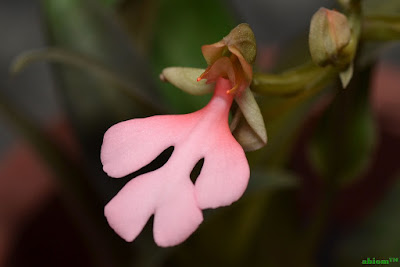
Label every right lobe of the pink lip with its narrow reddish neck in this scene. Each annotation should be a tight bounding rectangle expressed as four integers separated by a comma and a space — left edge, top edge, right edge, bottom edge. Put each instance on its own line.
187, 78, 250, 209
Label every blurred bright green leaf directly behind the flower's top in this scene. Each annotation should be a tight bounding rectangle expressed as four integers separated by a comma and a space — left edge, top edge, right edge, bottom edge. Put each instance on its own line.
150, 0, 235, 113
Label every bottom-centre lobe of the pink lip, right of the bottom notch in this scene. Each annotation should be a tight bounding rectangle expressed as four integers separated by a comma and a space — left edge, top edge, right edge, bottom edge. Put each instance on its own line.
153, 177, 203, 247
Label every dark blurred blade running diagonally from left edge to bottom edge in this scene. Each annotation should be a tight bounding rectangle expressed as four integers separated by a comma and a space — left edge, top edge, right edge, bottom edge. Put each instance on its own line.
0, 92, 128, 267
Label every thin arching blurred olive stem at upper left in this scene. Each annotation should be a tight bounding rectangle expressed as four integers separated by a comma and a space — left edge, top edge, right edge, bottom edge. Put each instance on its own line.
10, 48, 167, 114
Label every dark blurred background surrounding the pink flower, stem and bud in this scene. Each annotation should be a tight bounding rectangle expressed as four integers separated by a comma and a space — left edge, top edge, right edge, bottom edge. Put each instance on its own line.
0, 0, 400, 267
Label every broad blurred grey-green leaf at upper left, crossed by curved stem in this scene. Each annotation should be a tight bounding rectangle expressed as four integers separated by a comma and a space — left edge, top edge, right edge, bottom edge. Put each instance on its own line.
42, 0, 163, 197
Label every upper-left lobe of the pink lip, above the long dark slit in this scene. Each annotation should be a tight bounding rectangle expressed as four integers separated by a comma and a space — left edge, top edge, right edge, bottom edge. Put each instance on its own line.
101, 113, 198, 178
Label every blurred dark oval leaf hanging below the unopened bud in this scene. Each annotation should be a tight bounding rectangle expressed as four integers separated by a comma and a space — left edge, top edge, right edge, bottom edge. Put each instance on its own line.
309, 66, 375, 184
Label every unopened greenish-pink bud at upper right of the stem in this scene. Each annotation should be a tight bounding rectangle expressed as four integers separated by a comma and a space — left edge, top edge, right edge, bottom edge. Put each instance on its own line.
309, 8, 352, 67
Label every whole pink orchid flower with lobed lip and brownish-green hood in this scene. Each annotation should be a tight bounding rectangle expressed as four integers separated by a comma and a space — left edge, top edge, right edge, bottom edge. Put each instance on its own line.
101, 24, 266, 247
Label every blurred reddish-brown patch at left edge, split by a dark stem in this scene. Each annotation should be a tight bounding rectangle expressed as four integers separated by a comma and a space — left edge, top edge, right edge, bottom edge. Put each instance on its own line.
0, 119, 78, 266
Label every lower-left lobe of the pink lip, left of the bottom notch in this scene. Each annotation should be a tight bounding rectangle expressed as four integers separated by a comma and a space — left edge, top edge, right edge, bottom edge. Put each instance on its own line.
104, 170, 162, 242
